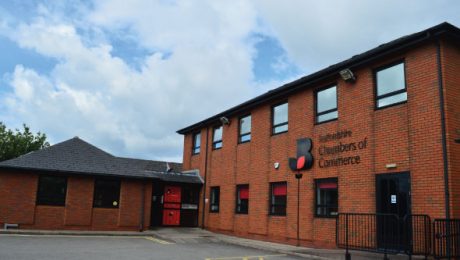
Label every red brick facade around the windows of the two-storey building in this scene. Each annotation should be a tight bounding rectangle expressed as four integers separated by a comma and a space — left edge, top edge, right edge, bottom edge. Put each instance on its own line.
183, 41, 460, 246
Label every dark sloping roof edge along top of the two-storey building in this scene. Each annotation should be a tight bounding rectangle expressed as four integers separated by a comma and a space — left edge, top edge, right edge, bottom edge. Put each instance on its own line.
177, 22, 460, 134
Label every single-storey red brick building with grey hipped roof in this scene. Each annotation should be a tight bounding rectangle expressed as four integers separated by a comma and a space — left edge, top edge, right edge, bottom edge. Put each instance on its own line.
0, 137, 203, 231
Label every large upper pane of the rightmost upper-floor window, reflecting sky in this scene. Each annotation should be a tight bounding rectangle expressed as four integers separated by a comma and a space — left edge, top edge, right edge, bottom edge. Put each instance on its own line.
377, 63, 405, 96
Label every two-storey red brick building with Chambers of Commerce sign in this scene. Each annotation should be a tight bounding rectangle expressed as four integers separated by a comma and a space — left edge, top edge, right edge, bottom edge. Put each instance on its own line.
178, 23, 460, 246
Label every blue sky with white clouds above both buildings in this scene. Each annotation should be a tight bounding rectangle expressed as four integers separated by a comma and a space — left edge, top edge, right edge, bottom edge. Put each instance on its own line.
0, 0, 460, 161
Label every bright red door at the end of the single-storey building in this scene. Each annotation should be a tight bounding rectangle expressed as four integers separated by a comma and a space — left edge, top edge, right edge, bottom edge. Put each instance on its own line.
163, 186, 181, 226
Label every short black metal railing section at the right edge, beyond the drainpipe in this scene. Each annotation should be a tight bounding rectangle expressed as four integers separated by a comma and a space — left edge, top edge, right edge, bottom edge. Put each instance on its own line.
433, 219, 460, 259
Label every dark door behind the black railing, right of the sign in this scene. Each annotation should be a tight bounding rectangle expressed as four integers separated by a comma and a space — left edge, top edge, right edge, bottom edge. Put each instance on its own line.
376, 173, 412, 251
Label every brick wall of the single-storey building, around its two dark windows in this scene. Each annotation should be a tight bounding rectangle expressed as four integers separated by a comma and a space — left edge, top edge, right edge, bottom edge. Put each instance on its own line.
0, 170, 152, 231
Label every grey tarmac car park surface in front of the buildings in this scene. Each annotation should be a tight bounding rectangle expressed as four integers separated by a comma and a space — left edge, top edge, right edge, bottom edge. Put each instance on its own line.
0, 228, 416, 260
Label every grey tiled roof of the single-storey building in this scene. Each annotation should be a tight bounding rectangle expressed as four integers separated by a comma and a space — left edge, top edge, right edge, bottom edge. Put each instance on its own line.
0, 137, 202, 183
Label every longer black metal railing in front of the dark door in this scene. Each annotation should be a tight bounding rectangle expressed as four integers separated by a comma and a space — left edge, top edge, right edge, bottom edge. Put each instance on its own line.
336, 213, 431, 259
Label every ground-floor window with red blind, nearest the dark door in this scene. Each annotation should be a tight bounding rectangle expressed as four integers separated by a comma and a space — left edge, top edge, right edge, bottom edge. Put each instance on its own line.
315, 178, 339, 217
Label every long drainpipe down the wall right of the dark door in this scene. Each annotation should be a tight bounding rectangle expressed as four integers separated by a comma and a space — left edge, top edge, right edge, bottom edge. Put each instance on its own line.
436, 39, 451, 259
